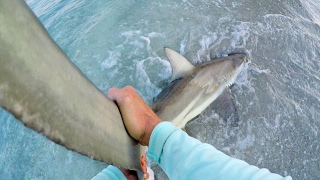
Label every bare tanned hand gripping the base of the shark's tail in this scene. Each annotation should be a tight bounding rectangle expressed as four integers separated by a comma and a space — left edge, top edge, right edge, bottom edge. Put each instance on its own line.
108, 86, 162, 146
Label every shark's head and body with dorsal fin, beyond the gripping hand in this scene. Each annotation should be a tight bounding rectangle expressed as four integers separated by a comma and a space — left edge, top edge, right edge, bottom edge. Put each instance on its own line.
152, 48, 246, 128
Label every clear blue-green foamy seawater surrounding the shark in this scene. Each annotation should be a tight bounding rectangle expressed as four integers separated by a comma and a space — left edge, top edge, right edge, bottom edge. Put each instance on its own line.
0, 0, 320, 179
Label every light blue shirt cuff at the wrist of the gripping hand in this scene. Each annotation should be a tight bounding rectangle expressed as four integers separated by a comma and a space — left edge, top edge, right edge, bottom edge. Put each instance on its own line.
147, 121, 179, 163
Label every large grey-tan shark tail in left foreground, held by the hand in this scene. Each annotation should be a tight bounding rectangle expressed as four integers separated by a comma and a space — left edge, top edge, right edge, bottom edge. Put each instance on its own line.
0, 0, 143, 170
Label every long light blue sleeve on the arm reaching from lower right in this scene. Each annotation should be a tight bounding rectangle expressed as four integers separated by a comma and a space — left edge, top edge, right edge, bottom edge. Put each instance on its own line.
147, 122, 292, 180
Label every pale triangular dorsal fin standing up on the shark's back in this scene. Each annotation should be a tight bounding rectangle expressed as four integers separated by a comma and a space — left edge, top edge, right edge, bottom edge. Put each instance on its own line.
164, 48, 196, 81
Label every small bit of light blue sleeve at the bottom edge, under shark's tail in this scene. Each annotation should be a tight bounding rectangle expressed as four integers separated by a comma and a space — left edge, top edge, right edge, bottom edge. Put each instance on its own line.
91, 165, 127, 180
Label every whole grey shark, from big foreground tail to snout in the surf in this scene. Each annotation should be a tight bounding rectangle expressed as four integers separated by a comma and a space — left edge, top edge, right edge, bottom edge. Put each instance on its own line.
0, 0, 245, 173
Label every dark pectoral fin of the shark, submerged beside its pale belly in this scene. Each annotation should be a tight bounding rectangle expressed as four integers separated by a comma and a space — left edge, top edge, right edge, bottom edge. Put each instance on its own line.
212, 89, 239, 127
